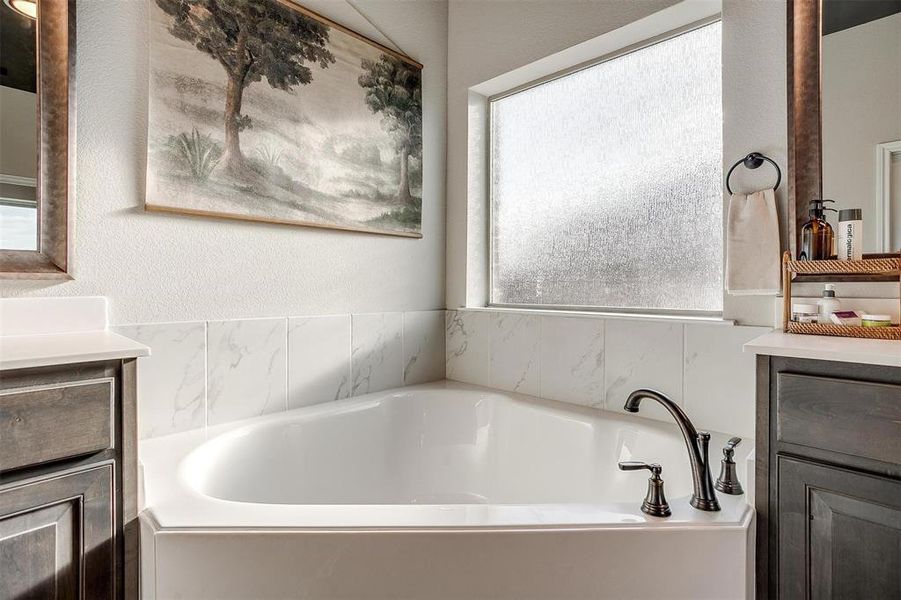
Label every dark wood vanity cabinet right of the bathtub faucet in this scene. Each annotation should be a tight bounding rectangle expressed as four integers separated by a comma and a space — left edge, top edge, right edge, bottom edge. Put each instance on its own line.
756, 356, 901, 600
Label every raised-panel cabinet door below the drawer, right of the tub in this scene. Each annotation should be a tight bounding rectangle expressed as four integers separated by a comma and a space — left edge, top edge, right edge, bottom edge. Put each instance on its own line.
778, 457, 901, 599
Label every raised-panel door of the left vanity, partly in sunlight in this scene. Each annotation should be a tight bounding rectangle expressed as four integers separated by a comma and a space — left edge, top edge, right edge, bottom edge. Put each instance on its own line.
0, 464, 116, 600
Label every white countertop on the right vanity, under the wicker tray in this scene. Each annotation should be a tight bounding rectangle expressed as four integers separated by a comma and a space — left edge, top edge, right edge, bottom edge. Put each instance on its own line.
744, 330, 901, 367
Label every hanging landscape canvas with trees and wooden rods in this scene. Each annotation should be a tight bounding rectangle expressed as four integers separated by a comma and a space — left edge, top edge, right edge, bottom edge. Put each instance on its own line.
145, 0, 422, 237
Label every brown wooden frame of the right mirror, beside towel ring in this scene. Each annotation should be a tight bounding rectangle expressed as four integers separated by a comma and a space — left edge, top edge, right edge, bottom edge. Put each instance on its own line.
786, 0, 898, 282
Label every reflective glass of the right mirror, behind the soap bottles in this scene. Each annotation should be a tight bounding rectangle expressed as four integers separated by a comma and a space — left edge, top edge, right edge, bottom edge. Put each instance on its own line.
820, 0, 901, 253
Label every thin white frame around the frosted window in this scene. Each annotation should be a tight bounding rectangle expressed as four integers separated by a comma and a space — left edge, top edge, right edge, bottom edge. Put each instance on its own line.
485, 12, 725, 317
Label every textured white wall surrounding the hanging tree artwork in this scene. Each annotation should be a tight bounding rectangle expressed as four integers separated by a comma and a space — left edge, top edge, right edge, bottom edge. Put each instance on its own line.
0, 0, 447, 324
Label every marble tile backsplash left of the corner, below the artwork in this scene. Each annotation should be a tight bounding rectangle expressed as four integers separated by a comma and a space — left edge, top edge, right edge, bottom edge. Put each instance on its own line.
113, 310, 445, 438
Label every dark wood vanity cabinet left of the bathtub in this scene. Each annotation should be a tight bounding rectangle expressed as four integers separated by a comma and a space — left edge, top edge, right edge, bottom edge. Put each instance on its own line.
0, 359, 138, 600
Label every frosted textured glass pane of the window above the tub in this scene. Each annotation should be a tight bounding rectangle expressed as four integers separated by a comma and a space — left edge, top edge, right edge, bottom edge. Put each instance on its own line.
490, 22, 723, 312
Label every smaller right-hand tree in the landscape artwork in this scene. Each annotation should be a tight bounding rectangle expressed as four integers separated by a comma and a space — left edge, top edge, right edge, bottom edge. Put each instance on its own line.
358, 54, 422, 204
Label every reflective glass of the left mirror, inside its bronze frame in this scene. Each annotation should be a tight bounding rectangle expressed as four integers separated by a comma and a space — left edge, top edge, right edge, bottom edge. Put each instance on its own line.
0, 0, 38, 251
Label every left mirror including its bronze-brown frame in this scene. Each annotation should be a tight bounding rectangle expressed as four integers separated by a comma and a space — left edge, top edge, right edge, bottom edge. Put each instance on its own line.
0, 0, 75, 279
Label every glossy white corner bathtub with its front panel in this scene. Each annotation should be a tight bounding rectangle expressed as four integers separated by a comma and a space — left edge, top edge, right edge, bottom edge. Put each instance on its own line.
140, 382, 753, 600
